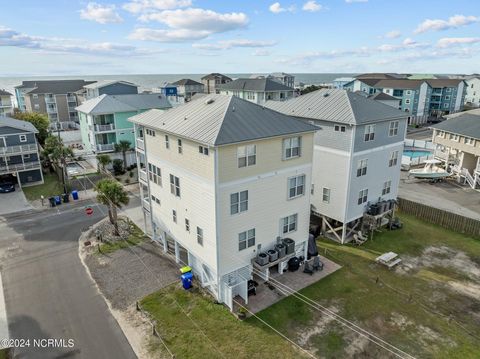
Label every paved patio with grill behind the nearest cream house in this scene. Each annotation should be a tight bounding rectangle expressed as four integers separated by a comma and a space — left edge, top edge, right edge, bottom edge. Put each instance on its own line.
244, 256, 341, 313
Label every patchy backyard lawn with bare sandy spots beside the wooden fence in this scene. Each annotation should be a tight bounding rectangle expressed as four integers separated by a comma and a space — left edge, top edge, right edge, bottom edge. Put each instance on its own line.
253, 215, 480, 358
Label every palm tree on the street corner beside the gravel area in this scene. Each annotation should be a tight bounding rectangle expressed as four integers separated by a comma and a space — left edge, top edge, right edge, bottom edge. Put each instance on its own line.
95, 179, 130, 236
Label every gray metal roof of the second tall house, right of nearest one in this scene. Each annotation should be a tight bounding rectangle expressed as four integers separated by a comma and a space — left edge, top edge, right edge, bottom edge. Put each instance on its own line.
265, 89, 408, 125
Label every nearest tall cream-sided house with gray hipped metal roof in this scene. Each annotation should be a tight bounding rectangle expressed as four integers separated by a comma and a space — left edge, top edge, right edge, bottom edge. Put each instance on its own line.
130, 95, 316, 308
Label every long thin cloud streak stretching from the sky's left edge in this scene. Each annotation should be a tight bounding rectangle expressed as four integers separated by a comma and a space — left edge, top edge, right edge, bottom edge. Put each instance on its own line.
0, 26, 154, 56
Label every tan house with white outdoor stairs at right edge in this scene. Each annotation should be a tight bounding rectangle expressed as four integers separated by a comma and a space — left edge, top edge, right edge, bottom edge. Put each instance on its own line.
431, 110, 480, 188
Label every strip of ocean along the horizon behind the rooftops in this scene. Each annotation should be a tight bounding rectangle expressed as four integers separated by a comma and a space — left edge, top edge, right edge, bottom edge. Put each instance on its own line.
0, 73, 355, 94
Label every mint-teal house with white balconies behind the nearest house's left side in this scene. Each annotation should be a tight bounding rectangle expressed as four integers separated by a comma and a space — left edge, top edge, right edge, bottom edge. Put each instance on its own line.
76, 94, 172, 154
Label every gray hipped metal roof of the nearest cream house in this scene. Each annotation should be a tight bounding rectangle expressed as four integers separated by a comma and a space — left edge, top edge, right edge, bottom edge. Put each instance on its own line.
129, 95, 317, 146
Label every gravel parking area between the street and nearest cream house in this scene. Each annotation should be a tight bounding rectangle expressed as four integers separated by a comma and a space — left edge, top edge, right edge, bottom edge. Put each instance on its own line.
82, 229, 180, 310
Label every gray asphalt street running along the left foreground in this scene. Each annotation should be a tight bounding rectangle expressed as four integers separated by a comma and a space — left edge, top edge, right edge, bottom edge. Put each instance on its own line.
0, 203, 135, 359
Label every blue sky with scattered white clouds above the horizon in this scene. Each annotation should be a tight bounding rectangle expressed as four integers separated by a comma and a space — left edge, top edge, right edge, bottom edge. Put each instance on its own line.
0, 0, 480, 76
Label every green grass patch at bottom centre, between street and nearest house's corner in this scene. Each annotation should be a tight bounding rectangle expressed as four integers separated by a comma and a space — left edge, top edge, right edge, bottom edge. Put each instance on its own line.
141, 285, 305, 359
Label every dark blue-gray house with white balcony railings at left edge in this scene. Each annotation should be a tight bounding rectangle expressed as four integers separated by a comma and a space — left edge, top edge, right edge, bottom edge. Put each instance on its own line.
0, 116, 43, 187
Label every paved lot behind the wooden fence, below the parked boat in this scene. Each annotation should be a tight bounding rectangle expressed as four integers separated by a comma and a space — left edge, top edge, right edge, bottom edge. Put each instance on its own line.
398, 172, 480, 220
